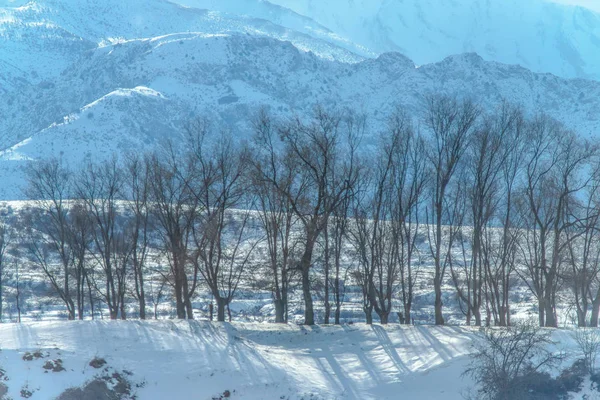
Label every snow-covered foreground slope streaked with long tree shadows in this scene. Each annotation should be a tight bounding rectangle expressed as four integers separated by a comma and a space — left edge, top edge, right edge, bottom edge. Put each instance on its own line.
0, 321, 474, 400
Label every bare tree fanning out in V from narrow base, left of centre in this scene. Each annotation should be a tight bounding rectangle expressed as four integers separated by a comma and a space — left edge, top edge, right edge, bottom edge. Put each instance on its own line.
190, 128, 258, 321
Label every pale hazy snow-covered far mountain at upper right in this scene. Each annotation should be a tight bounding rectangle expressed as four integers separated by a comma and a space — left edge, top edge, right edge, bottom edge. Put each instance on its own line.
268, 0, 600, 79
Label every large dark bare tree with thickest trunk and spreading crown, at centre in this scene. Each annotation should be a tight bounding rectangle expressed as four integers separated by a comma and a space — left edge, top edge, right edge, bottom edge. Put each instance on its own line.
254, 107, 364, 325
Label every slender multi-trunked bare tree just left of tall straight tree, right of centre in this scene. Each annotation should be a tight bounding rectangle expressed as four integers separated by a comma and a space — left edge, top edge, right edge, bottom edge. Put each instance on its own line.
350, 110, 427, 324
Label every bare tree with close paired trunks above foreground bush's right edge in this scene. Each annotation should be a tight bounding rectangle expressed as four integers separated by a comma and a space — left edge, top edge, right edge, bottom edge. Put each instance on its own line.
521, 117, 596, 327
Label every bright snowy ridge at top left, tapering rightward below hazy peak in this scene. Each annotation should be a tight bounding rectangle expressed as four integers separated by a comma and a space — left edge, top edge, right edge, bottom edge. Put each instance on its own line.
0, 0, 361, 83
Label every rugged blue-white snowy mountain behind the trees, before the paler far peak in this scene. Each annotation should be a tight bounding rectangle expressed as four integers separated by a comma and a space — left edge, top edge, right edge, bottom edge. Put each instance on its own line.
0, 0, 600, 198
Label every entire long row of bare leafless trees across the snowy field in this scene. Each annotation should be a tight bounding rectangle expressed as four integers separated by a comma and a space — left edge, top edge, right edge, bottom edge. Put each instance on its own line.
14, 96, 600, 326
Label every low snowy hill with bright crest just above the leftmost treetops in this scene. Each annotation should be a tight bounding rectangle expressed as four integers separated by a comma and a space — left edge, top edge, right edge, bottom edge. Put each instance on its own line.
2, 87, 181, 165
